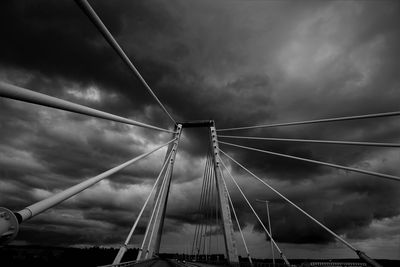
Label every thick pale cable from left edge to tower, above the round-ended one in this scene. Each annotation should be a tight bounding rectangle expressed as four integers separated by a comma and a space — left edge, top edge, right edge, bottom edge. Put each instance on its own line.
0, 81, 173, 133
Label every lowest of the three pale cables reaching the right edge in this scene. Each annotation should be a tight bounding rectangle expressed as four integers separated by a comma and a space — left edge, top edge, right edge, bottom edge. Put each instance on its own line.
219, 141, 400, 182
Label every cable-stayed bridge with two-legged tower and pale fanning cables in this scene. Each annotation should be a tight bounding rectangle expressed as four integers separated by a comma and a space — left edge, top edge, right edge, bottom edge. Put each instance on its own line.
0, 0, 400, 267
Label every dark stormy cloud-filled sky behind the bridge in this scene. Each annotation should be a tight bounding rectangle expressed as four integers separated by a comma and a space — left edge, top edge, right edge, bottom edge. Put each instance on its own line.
0, 0, 400, 259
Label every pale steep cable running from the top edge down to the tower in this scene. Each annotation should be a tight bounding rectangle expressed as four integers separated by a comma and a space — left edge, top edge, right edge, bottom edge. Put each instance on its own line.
75, 0, 176, 124
